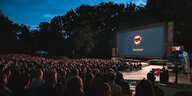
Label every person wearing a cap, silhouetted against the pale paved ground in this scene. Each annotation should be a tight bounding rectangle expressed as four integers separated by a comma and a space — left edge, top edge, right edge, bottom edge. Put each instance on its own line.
147, 72, 164, 96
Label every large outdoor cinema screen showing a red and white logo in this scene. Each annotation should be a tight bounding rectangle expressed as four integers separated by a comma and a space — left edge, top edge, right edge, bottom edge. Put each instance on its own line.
117, 24, 174, 58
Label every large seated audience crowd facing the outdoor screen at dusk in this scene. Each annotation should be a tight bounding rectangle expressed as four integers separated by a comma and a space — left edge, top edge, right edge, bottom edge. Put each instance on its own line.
0, 54, 167, 96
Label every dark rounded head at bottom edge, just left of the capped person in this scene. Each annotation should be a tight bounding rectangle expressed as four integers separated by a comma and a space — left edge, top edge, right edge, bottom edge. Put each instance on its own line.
135, 79, 155, 96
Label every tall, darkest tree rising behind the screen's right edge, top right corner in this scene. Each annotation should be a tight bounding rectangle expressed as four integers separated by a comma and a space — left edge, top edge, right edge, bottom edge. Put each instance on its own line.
146, 0, 192, 52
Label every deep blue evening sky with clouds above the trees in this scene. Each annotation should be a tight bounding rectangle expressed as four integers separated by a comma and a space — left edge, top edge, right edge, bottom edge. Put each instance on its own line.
0, 0, 147, 29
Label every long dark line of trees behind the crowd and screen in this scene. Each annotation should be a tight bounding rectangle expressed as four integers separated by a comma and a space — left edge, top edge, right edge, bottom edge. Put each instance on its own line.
0, 0, 192, 58
